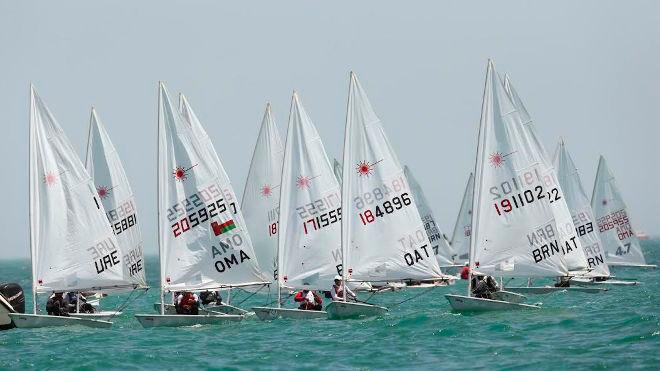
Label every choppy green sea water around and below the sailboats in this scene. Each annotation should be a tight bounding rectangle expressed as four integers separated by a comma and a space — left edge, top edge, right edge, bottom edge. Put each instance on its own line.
0, 240, 660, 370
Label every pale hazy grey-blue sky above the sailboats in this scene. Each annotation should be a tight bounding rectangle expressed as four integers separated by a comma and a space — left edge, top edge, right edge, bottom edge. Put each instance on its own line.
0, 0, 660, 258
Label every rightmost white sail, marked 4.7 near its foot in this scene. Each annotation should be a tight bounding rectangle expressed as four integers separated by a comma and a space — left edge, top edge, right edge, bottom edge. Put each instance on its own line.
591, 156, 646, 266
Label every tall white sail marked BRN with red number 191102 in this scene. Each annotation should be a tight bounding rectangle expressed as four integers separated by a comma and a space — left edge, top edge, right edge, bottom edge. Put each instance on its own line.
470, 61, 582, 277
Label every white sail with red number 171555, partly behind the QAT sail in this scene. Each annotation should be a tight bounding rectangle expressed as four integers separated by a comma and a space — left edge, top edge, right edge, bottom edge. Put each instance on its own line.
278, 92, 342, 289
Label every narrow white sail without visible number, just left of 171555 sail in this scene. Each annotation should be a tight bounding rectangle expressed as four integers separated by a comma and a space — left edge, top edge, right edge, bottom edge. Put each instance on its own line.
241, 103, 284, 279
